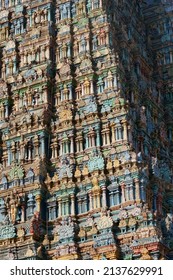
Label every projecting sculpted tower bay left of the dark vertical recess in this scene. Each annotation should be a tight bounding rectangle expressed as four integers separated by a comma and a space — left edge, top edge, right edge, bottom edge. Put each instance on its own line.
0, 1, 54, 259
